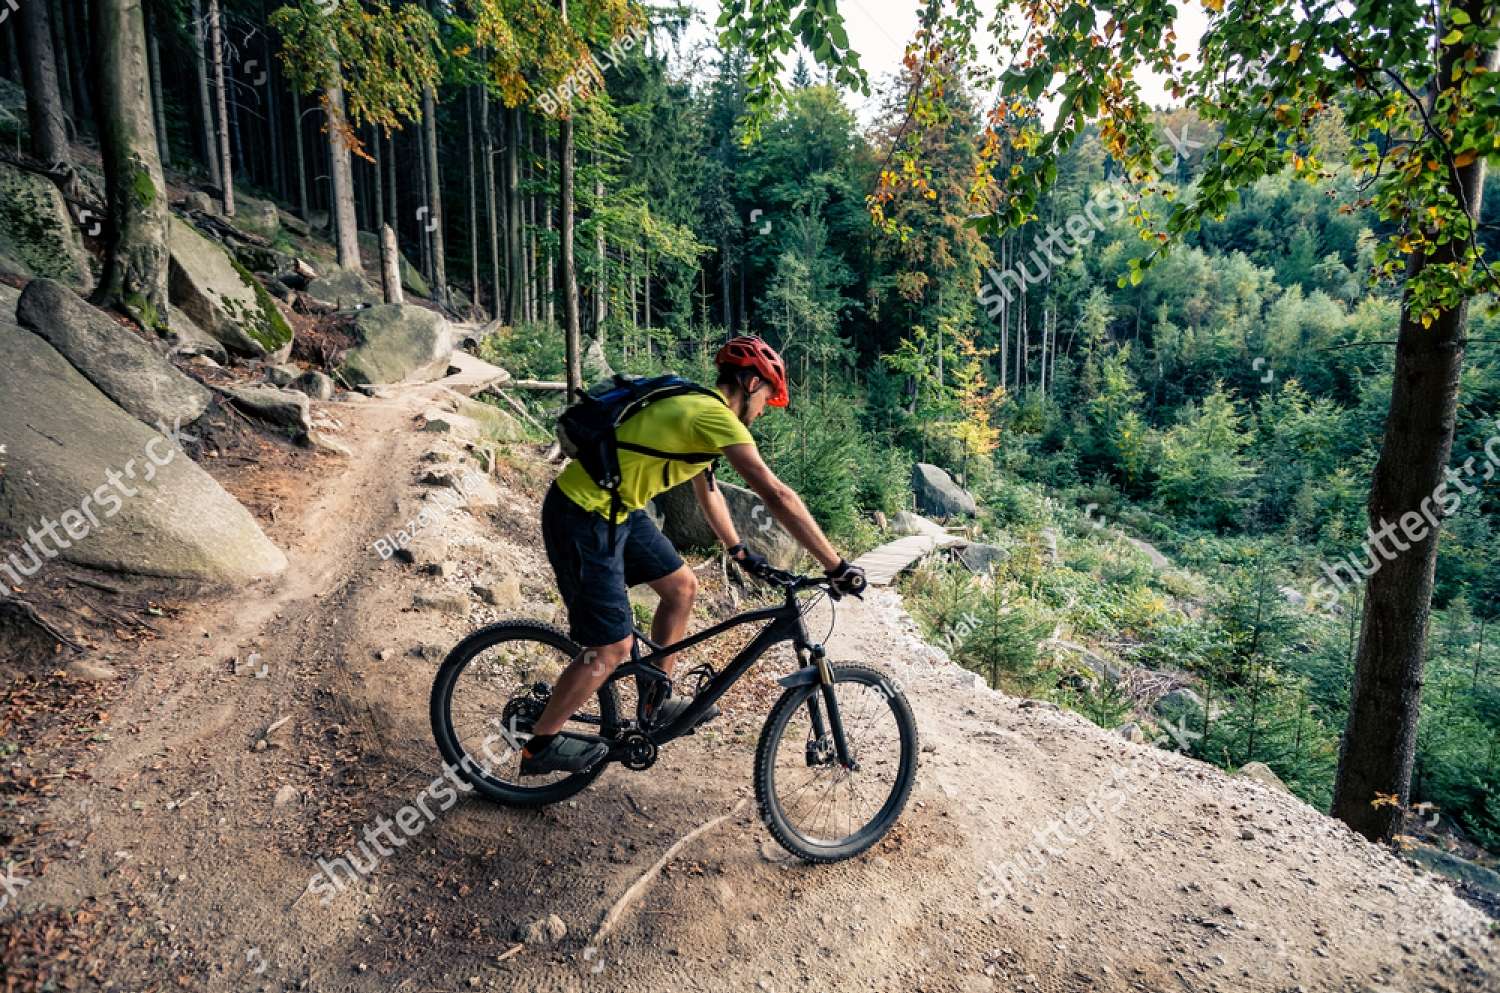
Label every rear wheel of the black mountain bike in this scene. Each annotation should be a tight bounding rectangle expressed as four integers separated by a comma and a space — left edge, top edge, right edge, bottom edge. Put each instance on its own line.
429, 621, 620, 807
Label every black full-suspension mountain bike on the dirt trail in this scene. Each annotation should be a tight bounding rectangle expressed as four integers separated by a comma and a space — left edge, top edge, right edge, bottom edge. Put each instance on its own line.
431, 569, 918, 863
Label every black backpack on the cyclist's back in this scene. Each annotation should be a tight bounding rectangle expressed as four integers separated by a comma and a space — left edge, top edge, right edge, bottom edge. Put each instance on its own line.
557, 374, 723, 548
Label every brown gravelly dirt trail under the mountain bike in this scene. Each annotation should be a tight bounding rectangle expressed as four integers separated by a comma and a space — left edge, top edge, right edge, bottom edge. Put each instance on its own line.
20, 375, 1497, 993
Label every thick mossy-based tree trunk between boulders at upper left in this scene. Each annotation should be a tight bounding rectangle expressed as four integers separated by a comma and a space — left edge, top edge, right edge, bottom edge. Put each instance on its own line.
93, 0, 168, 329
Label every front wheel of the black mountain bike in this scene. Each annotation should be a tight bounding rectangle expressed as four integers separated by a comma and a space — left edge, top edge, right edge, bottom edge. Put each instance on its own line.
755, 663, 918, 863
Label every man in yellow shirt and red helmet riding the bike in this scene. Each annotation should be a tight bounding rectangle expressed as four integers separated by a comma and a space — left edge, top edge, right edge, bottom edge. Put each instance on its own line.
521, 335, 864, 776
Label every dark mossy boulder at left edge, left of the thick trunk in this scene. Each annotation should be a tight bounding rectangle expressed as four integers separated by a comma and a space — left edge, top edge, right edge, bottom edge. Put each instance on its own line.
0, 162, 95, 293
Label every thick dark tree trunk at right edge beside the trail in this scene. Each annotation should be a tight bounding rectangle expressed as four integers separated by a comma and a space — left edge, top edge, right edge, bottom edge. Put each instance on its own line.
1332, 17, 1496, 840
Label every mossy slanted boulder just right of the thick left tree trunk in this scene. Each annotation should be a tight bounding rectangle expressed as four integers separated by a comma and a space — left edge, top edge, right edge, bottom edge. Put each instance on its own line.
170, 216, 291, 359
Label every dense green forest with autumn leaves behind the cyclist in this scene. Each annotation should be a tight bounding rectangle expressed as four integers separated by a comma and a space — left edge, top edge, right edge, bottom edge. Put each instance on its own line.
0, 0, 1500, 894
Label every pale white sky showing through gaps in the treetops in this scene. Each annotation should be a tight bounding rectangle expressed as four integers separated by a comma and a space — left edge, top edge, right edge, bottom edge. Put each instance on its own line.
689, 0, 1205, 125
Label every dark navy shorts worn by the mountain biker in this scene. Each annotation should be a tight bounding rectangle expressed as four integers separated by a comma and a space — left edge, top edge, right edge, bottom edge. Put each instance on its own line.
542, 483, 683, 648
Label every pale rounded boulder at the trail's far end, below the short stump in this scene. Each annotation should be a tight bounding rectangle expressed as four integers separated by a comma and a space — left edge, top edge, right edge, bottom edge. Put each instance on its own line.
339, 303, 453, 386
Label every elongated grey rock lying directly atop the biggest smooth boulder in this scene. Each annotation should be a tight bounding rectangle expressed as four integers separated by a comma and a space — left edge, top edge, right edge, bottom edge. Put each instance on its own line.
17, 279, 210, 429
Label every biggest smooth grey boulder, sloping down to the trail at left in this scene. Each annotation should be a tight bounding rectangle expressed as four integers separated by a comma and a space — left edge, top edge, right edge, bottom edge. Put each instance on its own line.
0, 324, 287, 585
